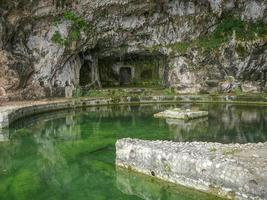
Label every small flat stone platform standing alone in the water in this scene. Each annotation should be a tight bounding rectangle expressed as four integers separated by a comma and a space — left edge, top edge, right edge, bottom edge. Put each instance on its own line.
154, 108, 209, 120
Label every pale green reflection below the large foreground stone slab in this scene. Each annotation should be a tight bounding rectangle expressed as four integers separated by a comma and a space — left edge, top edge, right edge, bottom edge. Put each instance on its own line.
117, 168, 218, 200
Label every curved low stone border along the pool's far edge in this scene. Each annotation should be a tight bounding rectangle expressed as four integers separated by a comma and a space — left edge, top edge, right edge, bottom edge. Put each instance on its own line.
0, 95, 267, 129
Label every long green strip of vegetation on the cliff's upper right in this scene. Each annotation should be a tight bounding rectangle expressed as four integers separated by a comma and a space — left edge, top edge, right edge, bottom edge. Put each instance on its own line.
148, 15, 267, 56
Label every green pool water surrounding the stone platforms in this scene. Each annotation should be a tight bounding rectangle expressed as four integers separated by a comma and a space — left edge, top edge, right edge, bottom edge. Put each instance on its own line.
0, 104, 267, 200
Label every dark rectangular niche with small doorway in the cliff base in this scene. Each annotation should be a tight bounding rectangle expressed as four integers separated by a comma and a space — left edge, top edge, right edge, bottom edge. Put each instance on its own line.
99, 53, 165, 87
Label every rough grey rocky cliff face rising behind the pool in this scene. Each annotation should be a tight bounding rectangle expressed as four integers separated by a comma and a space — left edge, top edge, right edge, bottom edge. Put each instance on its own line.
0, 0, 267, 99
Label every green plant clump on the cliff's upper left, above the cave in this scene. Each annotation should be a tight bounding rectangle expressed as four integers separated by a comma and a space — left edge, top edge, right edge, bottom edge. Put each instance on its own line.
52, 11, 92, 46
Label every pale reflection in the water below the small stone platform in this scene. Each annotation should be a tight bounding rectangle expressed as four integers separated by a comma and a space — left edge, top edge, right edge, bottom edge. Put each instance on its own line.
166, 117, 208, 142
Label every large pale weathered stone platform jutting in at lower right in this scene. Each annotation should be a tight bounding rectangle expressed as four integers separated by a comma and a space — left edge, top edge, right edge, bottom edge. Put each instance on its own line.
116, 139, 267, 199
